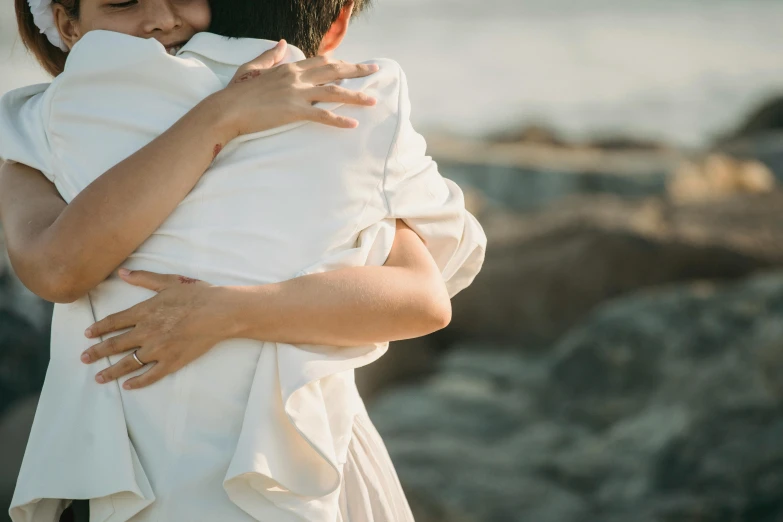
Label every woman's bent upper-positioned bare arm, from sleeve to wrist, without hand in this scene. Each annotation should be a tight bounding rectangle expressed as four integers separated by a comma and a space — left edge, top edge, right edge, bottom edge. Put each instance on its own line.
0, 98, 229, 302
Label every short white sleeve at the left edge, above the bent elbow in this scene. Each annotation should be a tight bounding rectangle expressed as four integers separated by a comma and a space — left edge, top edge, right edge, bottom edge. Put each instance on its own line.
0, 84, 54, 182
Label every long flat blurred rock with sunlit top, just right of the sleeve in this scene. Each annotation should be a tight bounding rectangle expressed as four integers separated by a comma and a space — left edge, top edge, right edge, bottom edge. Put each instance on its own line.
428, 136, 685, 212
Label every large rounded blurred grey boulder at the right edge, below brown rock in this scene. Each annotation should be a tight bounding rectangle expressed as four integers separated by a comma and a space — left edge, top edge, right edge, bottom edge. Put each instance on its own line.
552, 274, 783, 429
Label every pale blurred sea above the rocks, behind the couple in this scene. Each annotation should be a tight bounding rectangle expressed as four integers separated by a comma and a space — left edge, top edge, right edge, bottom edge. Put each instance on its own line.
0, 0, 783, 146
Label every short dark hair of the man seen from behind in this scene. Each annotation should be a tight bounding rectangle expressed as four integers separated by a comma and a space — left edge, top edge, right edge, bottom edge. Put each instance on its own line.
209, 0, 371, 57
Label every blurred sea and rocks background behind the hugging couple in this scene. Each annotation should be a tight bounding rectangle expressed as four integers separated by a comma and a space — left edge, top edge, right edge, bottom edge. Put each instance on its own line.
0, 0, 783, 522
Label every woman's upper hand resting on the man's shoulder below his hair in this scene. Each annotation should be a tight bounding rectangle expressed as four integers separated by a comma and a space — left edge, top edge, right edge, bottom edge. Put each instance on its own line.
210, 40, 378, 137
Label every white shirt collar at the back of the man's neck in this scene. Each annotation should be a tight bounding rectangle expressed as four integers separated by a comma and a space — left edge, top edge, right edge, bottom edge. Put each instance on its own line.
177, 33, 305, 66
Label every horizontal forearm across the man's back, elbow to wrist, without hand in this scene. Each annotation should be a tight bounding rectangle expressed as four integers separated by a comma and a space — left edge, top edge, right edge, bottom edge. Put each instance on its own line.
218, 267, 451, 346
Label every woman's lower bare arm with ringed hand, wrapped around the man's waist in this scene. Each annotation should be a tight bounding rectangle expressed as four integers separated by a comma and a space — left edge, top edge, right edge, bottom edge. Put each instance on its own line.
82, 222, 451, 388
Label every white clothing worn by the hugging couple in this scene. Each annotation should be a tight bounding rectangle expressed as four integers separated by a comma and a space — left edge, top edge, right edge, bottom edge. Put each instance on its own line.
0, 31, 486, 522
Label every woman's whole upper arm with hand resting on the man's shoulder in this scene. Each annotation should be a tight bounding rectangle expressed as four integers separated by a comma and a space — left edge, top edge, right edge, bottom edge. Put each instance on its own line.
0, 45, 374, 303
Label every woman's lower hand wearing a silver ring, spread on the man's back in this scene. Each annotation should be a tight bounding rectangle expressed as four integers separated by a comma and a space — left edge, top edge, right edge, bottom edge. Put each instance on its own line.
82, 270, 230, 390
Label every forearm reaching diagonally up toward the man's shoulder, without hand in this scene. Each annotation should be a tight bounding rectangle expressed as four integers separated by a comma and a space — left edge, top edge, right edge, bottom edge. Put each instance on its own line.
15, 96, 231, 302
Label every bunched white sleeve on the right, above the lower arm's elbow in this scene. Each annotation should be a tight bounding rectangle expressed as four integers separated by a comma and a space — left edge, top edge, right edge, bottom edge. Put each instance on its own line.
383, 69, 487, 297
